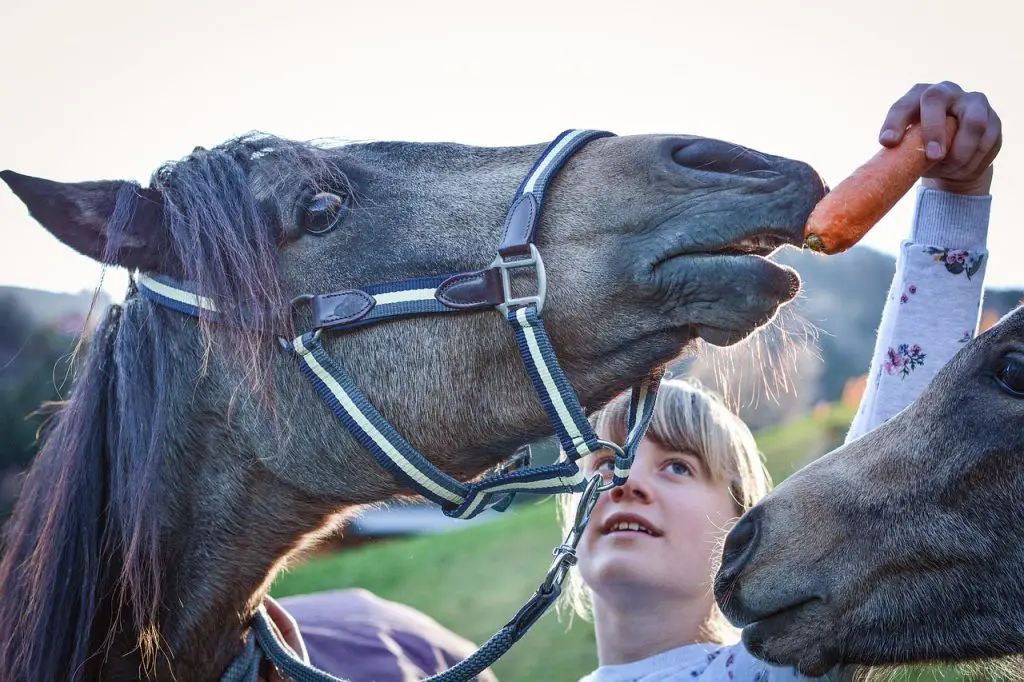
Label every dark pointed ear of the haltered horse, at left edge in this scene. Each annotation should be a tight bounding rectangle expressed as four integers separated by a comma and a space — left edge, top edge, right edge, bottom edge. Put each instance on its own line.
0, 170, 174, 274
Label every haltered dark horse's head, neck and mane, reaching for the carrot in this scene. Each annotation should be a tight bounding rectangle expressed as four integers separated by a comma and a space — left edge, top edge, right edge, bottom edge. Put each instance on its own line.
0, 130, 824, 682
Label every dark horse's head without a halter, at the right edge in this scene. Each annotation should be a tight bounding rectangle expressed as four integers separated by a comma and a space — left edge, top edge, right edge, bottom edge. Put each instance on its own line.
716, 308, 1024, 674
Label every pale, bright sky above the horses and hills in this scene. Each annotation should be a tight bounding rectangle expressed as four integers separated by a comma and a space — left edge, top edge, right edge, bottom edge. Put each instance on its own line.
0, 0, 1024, 299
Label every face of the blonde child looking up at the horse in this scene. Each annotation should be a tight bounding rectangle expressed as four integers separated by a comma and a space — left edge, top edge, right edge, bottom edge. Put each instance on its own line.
579, 438, 738, 610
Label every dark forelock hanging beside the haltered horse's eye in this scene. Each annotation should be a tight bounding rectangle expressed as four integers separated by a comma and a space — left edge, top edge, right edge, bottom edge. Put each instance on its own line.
110, 134, 347, 389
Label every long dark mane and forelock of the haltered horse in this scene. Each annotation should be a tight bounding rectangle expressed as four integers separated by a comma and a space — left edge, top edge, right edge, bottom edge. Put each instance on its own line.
0, 130, 337, 682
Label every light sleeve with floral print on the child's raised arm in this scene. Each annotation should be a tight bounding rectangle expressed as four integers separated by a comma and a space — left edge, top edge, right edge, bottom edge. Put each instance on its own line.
846, 187, 992, 442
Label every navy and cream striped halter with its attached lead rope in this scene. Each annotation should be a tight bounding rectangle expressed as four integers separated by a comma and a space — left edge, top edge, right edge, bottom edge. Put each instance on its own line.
135, 130, 663, 682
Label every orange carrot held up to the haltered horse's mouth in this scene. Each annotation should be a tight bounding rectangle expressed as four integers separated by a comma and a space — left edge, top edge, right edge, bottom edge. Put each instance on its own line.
804, 116, 956, 254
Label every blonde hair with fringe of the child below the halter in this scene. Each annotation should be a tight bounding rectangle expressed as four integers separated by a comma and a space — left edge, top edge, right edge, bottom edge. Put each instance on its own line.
557, 379, 772, 643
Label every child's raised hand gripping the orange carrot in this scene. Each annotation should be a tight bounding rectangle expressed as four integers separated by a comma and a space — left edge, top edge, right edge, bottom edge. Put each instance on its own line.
879, 81, 1002, 195
